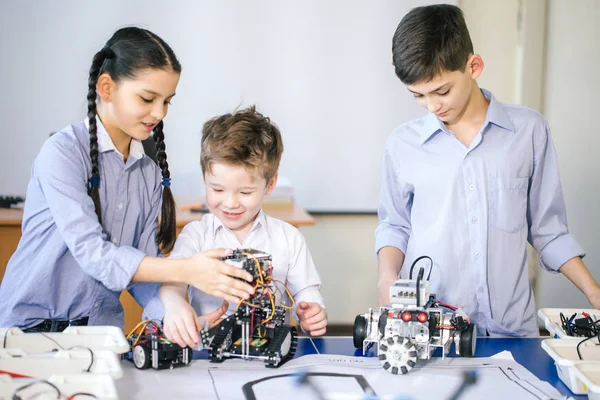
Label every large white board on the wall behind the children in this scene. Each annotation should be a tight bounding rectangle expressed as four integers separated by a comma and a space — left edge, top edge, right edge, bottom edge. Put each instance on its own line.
0, 0, 457, 212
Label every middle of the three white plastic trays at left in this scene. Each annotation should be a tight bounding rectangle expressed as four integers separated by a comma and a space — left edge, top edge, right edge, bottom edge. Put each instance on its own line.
0, 349, 123, 379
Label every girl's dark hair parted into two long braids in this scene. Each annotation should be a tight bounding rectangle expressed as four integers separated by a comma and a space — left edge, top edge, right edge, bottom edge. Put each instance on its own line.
87, 27, 181, 252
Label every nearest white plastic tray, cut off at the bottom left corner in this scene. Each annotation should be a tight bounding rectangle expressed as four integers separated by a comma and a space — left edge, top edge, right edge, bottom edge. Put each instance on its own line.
0, 374, 119, 400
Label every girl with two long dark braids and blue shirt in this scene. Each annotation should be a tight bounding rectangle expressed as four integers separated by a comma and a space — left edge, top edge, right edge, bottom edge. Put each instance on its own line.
0, 27, 254, 331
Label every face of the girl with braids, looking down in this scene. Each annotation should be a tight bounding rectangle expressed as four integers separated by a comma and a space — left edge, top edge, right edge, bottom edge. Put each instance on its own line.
98, 69, 179, 140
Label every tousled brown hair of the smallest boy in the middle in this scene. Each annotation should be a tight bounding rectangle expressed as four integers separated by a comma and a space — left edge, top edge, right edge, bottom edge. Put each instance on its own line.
200, 106, 283, 183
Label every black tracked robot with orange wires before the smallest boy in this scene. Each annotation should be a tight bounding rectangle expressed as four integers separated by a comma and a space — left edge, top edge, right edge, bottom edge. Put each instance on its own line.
200, 249, 298, 368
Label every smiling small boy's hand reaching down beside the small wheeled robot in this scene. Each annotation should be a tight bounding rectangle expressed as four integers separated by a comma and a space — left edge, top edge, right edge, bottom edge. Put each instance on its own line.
163, 299, 229, 348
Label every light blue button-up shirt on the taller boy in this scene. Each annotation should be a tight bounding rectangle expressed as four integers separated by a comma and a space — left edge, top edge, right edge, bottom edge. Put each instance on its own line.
375, 90, 583, 336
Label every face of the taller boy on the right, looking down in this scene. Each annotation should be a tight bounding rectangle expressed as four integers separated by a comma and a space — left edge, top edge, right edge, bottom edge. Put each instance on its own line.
406, 55, 483, 125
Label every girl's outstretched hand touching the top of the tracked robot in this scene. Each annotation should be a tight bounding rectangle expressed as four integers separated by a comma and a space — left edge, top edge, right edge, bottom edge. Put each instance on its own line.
185, 249, 254, 303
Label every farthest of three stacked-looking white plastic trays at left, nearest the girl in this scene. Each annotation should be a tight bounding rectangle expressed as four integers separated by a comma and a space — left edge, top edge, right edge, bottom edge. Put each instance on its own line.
0, 326, 129, 354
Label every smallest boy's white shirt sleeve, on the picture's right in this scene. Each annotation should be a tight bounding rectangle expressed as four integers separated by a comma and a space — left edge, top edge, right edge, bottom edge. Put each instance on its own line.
286, 226, 325, 318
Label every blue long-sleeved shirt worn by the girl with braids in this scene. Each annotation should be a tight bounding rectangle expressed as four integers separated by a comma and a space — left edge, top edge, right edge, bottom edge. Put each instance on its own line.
0, 119, 162, 328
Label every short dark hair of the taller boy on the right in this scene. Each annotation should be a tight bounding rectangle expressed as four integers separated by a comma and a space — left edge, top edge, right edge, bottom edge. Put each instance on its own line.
392, 4, 473, 85
